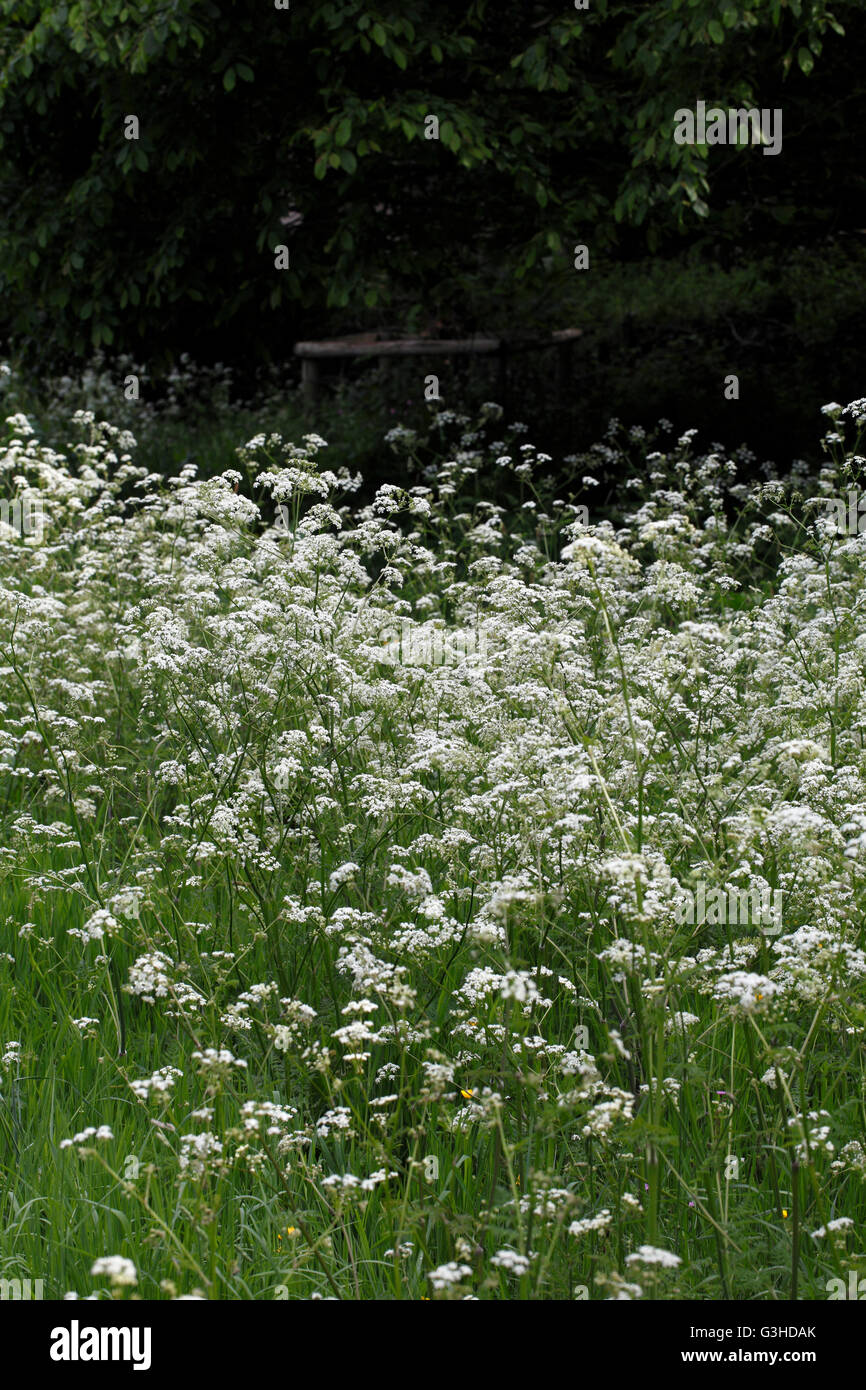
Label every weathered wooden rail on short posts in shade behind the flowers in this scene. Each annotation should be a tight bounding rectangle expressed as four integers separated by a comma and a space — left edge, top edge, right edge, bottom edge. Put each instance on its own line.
295, 328, 582, 400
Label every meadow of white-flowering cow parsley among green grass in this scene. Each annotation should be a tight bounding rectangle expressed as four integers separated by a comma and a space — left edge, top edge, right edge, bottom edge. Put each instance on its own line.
0, 375, 866, 1300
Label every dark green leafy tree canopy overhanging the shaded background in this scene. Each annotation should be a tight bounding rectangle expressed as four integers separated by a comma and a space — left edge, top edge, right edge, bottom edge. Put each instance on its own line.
0, 0, 866, 361
